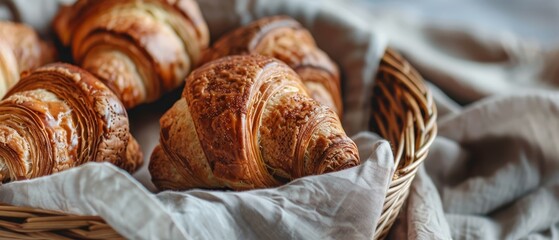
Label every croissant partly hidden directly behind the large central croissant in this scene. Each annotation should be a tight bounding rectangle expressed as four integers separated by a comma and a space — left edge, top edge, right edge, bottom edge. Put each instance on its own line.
202, 16, 343, 116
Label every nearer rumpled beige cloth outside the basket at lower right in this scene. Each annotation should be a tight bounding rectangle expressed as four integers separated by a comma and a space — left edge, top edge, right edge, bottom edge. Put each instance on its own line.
392, 92, 559, 239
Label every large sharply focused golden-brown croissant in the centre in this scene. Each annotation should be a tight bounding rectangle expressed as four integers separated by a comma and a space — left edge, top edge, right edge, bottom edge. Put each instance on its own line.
149, 55, 359, 190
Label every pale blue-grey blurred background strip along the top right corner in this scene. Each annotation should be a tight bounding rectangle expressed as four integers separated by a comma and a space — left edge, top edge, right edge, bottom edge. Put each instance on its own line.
354, 0, 559, 47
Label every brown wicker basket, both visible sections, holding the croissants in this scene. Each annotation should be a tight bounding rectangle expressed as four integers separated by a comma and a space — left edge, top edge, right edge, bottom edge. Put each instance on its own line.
0, 49, 437, 239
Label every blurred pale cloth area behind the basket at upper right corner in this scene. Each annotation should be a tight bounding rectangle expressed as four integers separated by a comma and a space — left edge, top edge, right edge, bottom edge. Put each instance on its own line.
355, 0, 559, 104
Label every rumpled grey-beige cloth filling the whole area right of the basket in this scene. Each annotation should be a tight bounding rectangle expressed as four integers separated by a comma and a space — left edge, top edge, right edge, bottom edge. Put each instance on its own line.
352, 0, 559, 239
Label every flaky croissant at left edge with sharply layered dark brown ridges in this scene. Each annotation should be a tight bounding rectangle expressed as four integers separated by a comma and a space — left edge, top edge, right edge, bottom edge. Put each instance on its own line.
0, 63, 142, 182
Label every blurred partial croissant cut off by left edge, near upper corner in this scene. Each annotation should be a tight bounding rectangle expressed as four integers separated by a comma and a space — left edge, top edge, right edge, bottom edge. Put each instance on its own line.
0, 21, 55, 98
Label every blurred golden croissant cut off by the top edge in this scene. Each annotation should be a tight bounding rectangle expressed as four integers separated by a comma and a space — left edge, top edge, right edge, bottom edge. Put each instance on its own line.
53, 0, 209, 108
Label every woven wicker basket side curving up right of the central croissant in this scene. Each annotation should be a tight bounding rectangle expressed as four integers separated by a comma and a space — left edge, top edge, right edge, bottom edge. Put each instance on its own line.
370, 49, 437, 239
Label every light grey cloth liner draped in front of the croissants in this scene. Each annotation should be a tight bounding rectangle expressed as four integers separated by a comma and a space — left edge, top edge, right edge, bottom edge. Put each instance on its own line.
0, 133, 394, 239
